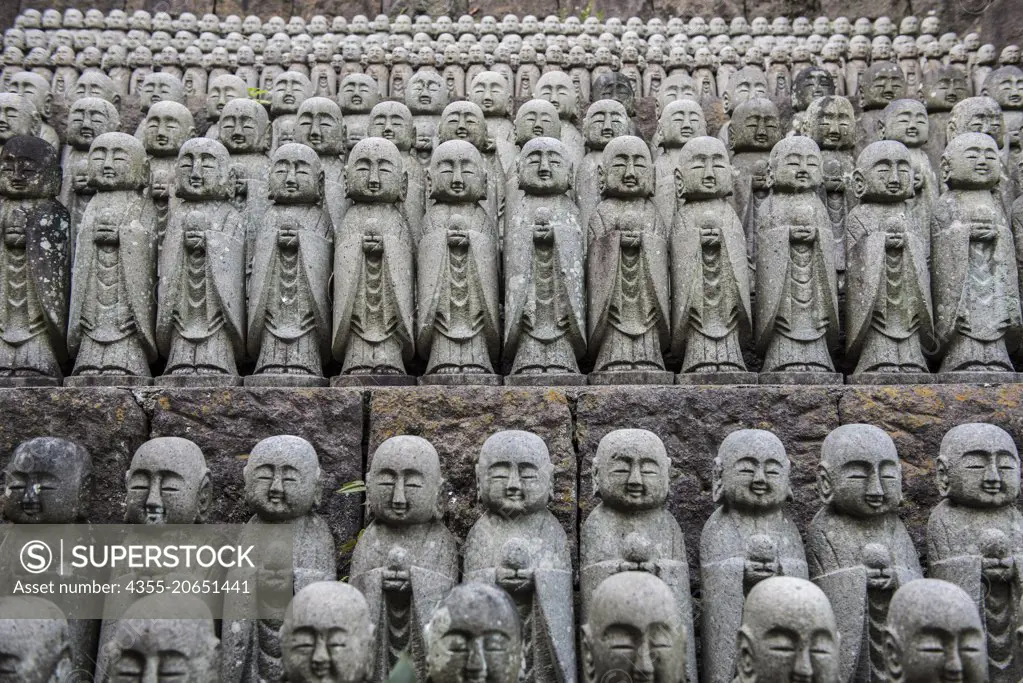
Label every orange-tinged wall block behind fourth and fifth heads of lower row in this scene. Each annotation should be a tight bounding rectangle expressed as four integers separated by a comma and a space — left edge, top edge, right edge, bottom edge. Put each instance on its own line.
368, 386, 576, 556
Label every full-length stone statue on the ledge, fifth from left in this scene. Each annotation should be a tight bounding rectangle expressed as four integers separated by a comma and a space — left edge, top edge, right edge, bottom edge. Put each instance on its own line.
335, 138, 417, 385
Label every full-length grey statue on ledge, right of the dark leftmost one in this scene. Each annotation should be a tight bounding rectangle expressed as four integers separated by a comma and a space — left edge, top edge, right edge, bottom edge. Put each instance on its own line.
64, 133, 157, 386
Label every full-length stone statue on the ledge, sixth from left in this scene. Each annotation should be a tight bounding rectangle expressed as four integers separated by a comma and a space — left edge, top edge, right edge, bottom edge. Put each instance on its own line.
416, 140, 501, 384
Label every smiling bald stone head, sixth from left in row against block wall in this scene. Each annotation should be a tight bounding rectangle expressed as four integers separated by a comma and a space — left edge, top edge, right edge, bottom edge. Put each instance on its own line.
592, 429, 671, 511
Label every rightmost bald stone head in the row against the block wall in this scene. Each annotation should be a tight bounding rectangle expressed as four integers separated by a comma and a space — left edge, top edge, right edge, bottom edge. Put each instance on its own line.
937, 423, 1020, 508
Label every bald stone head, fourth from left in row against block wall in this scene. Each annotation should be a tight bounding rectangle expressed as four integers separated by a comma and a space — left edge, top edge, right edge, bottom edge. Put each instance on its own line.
368, 435, 444, 527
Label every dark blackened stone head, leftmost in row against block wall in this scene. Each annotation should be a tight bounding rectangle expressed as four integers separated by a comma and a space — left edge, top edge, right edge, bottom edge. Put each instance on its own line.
4, 437, 92, 525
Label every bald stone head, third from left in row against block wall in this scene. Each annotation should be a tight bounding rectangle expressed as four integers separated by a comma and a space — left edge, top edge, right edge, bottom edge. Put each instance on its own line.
244, 435, 320, 521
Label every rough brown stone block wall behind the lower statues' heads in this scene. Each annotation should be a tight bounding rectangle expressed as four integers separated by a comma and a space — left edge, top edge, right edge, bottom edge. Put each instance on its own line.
7, 384, 1023, 589
